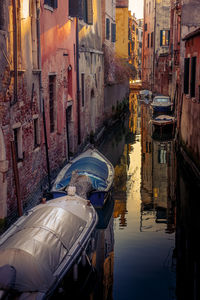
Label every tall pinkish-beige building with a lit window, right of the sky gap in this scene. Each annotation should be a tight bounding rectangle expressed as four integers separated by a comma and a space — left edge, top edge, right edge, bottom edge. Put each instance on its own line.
142, 0, 170, 95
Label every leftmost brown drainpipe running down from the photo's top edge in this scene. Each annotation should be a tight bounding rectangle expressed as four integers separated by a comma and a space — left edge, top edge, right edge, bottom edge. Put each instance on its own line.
12, 0, 18, 103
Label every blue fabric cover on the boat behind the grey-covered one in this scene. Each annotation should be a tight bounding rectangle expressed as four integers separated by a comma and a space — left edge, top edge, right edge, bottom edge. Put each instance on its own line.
56, 157, 108, 190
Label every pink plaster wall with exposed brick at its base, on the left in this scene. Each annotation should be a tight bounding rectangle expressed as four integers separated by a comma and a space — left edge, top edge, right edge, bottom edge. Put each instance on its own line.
41, 0, 77, 169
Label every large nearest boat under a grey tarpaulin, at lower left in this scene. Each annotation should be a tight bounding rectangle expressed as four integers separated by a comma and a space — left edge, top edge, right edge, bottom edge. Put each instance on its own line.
0, 192, 98, 300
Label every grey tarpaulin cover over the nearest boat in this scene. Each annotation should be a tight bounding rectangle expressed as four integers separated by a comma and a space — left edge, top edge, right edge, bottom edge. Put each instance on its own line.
0, 204, 87, 292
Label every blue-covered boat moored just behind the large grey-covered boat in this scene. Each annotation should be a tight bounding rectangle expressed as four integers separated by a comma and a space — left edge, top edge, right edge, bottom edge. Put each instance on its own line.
51, 148, 114, 207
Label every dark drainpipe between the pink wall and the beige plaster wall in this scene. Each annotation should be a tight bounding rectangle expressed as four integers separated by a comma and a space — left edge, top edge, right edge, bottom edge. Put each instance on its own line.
75, 17, 81, 145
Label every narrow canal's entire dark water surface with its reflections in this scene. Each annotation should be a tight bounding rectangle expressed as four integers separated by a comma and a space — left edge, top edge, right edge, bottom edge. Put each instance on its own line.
56, 93, 200, 300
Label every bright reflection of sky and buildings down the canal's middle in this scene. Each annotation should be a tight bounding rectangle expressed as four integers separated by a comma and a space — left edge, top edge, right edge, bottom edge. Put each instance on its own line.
113, 93, 175, 300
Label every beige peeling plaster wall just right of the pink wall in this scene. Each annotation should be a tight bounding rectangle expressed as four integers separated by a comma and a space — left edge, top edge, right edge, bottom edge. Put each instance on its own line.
79, 0, 104, 141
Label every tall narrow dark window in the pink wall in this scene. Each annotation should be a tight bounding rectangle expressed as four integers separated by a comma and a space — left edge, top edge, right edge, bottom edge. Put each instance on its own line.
49, 75, 56, 132
